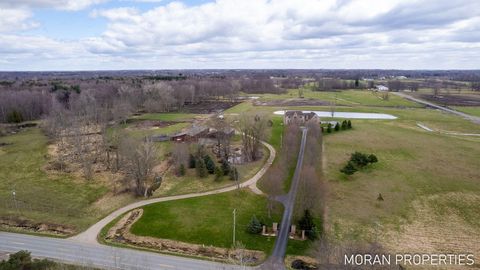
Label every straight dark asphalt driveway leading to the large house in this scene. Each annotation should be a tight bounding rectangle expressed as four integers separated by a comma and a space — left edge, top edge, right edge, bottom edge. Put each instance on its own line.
262, 128, 308, 270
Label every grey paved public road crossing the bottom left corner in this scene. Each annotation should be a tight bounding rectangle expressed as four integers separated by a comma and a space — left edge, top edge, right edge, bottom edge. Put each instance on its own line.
0, 232, 249, 270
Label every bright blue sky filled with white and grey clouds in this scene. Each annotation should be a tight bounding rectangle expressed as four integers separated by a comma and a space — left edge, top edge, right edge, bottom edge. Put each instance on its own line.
0, 0, 480, 71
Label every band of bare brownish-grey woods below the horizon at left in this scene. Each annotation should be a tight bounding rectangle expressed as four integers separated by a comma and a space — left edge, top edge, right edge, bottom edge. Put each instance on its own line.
0, 75, 284, 122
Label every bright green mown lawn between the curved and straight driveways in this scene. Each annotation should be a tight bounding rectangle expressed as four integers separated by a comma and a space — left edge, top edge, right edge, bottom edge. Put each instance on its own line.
132, 190, 280, 253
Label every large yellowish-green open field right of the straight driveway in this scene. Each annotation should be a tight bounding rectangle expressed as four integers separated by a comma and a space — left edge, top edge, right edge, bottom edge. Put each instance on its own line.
325, 109, 480, 256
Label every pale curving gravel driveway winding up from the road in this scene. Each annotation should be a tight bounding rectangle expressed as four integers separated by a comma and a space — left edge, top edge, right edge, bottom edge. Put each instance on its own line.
69, 141, 276, 244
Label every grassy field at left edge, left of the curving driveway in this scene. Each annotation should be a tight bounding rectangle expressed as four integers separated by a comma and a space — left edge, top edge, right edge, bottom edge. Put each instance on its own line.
0, 128, 112, 231
